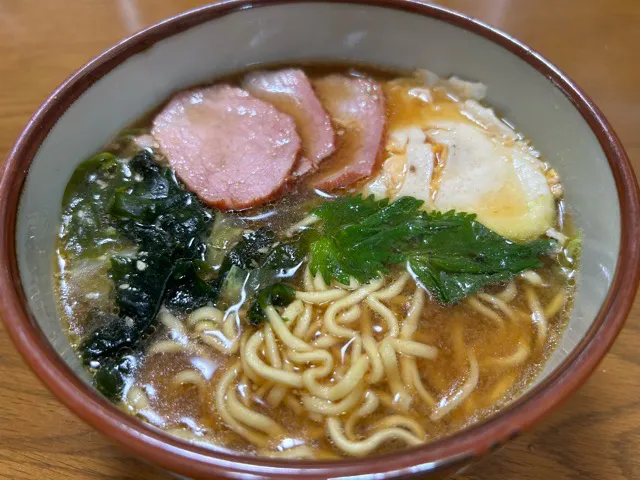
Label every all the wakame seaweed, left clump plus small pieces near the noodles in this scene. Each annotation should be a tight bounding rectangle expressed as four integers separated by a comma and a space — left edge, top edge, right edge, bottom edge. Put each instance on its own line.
61, 150, 303, 398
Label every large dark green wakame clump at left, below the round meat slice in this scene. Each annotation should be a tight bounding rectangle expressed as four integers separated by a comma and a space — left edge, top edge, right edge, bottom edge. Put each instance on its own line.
71, 151, 217, 396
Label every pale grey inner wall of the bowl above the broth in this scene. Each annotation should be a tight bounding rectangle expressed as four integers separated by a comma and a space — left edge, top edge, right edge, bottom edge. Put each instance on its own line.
16, 3, 620, 394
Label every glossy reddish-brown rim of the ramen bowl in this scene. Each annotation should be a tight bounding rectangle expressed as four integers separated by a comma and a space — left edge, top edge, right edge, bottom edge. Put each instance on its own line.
0, 0, 640, 479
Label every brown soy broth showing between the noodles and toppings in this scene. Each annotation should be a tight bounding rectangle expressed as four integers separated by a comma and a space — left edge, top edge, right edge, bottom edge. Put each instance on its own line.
54, 64, 576, 458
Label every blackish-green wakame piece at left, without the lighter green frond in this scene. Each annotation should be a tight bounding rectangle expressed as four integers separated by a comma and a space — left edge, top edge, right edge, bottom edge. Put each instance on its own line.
81, 151, 215, 361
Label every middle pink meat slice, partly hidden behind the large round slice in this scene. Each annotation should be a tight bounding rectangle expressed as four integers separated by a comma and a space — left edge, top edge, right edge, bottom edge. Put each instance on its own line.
243, 68, 335, 174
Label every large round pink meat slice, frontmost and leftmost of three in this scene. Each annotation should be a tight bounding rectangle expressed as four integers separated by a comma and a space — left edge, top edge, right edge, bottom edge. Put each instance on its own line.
152, 85, 300, 210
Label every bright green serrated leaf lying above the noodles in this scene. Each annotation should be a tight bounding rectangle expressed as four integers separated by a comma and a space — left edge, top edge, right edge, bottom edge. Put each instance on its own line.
309, 195, 556, 304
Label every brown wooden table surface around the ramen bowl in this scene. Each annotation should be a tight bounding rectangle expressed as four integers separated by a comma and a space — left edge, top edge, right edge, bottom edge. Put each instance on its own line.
0, 0, 640, 480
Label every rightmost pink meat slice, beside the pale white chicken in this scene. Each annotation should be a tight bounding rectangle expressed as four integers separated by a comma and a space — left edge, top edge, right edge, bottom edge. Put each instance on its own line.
310, 74, 385, 190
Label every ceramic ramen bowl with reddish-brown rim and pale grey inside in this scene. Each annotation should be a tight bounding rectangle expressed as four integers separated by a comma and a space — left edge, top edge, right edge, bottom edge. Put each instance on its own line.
0, 0, 640, 479
